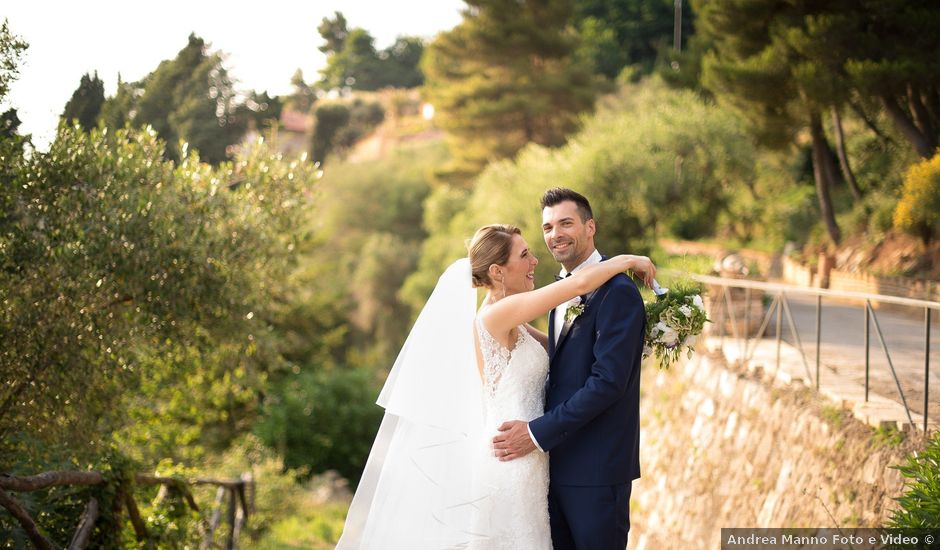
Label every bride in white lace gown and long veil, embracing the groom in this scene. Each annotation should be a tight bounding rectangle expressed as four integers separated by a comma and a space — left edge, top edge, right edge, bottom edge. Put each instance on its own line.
336, 225, 655, 550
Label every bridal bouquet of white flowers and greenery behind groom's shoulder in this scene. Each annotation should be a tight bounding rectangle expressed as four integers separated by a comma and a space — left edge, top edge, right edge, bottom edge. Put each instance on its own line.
643, 281, 708, 368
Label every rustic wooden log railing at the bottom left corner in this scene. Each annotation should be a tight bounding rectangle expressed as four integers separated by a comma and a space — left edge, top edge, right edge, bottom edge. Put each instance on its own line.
0, 471, 255, 550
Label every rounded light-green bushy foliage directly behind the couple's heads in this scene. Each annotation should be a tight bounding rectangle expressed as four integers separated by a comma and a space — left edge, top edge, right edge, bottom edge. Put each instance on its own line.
402, 80, 761, 308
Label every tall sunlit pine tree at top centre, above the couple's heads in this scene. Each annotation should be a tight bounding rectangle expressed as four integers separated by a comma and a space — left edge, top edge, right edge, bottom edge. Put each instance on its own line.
422, 0, 595, 182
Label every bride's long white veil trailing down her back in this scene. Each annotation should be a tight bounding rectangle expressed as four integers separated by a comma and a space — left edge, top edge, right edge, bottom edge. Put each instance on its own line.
336, 258, 490, 550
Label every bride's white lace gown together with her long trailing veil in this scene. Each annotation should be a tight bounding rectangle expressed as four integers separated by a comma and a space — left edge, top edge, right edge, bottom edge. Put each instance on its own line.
336, 258, 552, 550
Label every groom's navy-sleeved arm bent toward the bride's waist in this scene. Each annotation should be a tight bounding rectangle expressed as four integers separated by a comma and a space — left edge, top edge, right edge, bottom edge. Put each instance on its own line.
528, 276, 646, 451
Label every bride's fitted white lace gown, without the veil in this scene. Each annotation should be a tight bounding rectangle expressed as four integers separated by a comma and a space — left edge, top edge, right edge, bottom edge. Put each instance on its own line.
470, 318, 552, 550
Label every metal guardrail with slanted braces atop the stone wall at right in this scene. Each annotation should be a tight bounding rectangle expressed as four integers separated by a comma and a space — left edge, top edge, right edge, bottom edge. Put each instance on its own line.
686, 274, 940, 433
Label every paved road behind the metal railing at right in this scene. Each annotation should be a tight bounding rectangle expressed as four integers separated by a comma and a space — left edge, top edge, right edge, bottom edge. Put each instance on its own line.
720, 294, 940, 420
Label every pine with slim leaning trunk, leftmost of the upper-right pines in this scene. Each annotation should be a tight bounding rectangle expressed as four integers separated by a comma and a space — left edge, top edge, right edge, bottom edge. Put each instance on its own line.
696, 0, 844, 244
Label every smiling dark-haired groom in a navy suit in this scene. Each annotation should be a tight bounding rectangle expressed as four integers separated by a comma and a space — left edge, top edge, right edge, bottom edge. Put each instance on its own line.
493, 188, 646, 550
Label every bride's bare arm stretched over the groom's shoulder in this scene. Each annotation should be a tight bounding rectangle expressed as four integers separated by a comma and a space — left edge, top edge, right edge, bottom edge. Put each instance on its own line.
481, 254, 649, 336
